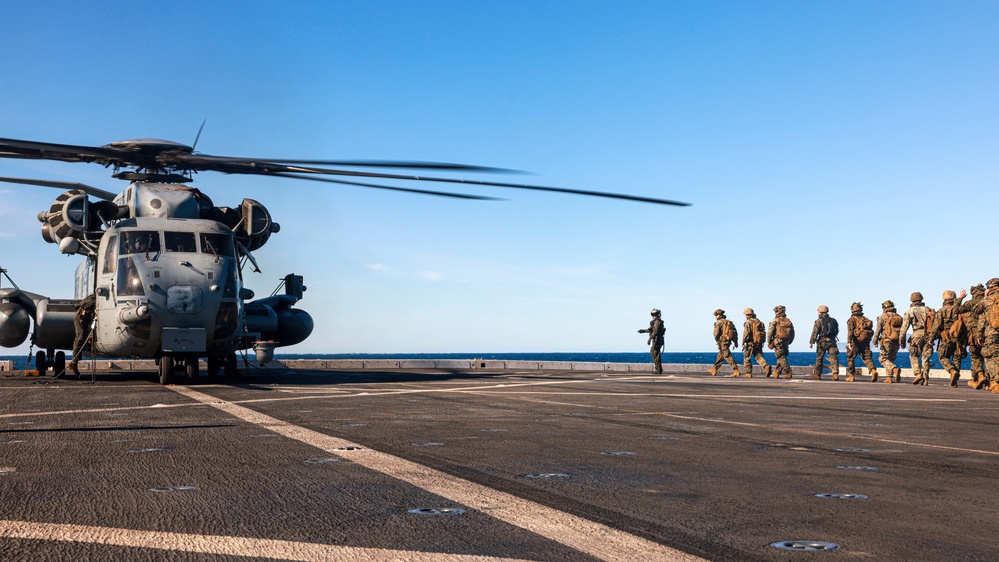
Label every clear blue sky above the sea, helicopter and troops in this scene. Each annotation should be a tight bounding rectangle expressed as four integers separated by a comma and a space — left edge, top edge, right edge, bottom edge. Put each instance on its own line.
0, 1, 999, 353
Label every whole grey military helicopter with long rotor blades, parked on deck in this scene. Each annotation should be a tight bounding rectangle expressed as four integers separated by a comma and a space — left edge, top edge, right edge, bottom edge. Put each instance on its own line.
0, 133, 688, 384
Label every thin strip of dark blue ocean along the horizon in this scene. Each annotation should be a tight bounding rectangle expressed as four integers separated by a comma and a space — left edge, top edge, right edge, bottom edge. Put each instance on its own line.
0, 351, 971, 369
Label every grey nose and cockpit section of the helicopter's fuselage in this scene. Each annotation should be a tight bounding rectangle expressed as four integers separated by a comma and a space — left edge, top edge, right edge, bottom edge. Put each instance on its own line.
92, 217, 244, 358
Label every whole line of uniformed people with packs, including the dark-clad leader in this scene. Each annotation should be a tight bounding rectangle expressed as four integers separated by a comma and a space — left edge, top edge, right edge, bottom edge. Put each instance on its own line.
639, 278, 999, 394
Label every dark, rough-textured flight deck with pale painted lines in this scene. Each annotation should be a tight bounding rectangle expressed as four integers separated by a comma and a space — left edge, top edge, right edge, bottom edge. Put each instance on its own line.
0, 364, 999, 561
